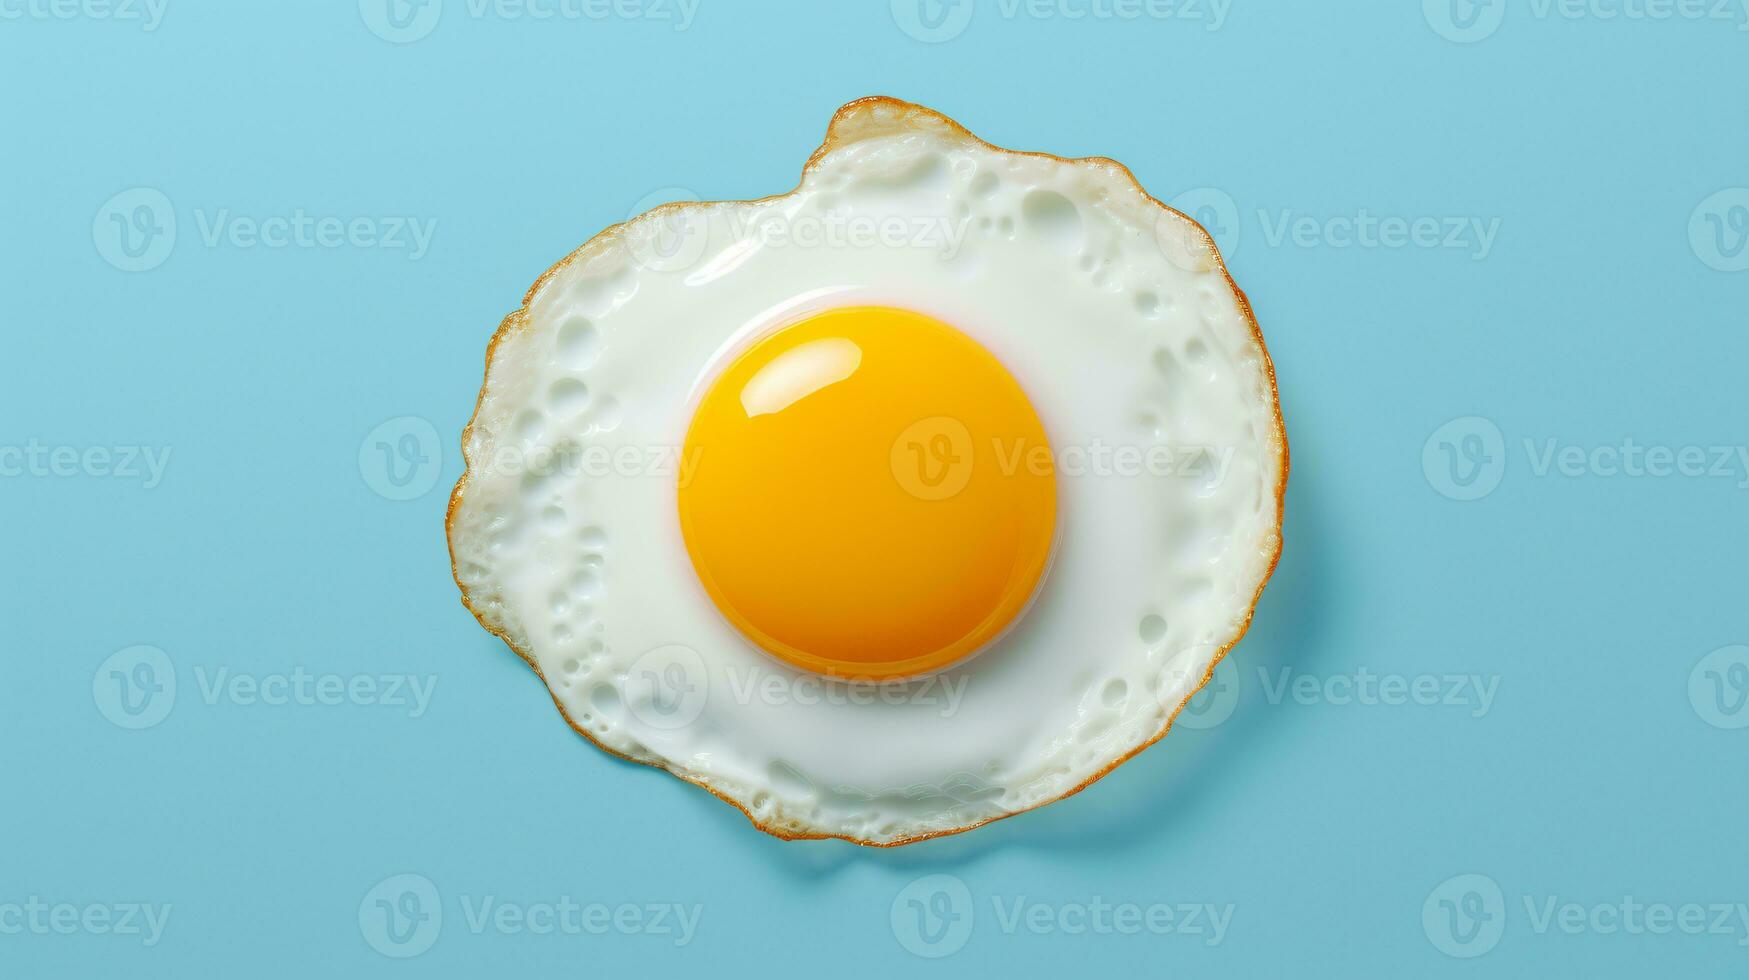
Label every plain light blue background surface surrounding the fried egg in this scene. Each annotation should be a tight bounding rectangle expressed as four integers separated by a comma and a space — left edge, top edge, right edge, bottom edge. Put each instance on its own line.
0, 0, 1749, 977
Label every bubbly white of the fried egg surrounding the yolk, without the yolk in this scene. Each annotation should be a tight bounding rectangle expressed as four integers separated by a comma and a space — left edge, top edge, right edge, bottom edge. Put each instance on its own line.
448, 100, 1287, 844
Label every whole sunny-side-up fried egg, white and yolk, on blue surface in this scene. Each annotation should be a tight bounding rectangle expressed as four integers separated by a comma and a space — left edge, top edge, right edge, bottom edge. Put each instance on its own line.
448, 98, 1287, 845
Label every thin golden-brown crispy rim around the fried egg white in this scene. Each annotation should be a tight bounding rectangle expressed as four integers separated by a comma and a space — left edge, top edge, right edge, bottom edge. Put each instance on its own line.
444, 96, 1289, 847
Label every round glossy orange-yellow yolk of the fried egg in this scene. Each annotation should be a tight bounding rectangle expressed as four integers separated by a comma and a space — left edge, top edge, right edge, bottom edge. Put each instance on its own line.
679, 306, 1056, 679
